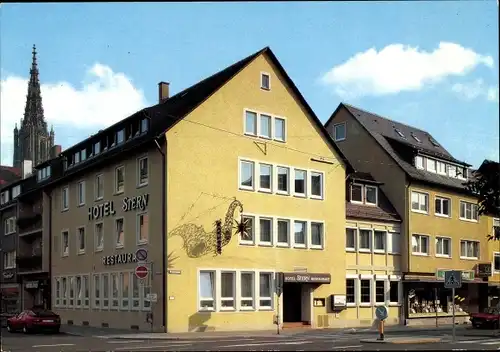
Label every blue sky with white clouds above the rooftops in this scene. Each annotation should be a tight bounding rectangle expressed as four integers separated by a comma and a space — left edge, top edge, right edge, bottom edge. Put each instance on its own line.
0, 0, 499, 166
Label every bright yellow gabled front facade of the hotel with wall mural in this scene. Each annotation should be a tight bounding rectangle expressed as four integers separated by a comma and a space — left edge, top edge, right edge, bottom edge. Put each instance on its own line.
165, 49, 346, 332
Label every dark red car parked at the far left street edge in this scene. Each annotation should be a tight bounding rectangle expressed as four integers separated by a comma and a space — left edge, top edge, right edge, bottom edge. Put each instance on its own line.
7, 309, 61, 334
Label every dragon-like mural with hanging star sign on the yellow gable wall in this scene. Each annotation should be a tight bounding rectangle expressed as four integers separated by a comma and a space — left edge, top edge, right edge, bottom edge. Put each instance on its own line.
169, 199, 249, 258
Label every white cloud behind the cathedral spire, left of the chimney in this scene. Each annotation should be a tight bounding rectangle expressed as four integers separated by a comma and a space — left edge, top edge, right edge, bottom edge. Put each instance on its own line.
0, 63, 147, 164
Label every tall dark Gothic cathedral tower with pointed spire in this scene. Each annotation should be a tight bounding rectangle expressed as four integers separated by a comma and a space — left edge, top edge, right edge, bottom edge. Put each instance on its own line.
13, 45, 54, 168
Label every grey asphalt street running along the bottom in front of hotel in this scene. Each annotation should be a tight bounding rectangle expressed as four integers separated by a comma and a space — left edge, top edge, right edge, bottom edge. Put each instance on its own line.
1, 330, 500, 352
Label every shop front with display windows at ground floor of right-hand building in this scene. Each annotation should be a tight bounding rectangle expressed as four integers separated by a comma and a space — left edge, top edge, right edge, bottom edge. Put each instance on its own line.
403, 270, 488, 326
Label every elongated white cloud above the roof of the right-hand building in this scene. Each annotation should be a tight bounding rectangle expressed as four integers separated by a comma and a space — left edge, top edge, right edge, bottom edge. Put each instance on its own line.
321, 42, 493, 97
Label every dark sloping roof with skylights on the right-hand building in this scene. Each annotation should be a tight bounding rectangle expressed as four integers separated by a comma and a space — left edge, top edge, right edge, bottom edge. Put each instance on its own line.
336, 103, 470, 190
